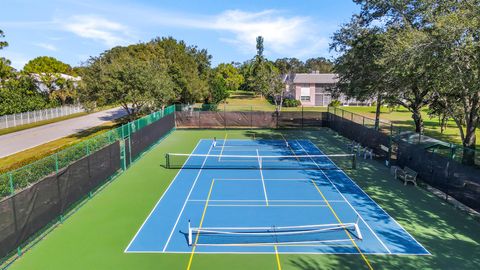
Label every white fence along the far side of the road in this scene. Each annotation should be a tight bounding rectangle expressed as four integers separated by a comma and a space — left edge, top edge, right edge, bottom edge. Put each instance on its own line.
0, 105, 84, 129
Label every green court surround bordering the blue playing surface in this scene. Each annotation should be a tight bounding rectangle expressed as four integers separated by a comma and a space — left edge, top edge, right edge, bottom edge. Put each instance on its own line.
9, 128, 480, 270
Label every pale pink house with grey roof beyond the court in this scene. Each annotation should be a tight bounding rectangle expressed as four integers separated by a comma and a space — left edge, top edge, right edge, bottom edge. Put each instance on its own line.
284, 71, 371, 106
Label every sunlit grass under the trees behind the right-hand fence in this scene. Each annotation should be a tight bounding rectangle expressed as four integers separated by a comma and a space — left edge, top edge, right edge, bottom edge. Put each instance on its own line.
342, 106, 480, 148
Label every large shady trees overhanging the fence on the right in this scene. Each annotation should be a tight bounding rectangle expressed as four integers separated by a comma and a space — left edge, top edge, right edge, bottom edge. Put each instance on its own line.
331, 0, 480, 163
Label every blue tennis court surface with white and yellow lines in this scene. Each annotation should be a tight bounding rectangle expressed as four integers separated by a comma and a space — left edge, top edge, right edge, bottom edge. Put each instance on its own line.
125, 140, 430, 255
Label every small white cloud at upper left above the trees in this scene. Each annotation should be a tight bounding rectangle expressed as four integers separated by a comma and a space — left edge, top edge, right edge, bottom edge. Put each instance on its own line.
61, 15, 132, 47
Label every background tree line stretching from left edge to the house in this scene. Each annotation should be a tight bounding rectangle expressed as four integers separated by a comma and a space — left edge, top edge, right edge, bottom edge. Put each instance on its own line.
0, 26, 332, 118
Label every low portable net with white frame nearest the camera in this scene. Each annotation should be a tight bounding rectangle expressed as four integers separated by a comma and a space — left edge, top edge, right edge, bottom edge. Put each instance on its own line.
188, 220, 363, 246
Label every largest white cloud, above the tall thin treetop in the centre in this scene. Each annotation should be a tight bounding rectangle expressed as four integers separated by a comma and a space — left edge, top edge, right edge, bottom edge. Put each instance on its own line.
150, 10, 330, 57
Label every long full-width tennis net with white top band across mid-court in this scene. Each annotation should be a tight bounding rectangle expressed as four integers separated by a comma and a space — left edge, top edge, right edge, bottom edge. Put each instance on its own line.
165, 153, 357, 170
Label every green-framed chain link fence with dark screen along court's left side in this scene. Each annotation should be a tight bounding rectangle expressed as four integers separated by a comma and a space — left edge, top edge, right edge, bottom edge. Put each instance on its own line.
0, 106, 175, 266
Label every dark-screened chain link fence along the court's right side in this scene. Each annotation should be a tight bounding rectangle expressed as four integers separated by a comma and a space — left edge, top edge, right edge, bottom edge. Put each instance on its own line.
327, 107, 480, 211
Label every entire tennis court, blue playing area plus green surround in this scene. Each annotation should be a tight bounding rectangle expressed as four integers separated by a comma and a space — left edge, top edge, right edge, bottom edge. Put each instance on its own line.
9, 129, 480, 270
